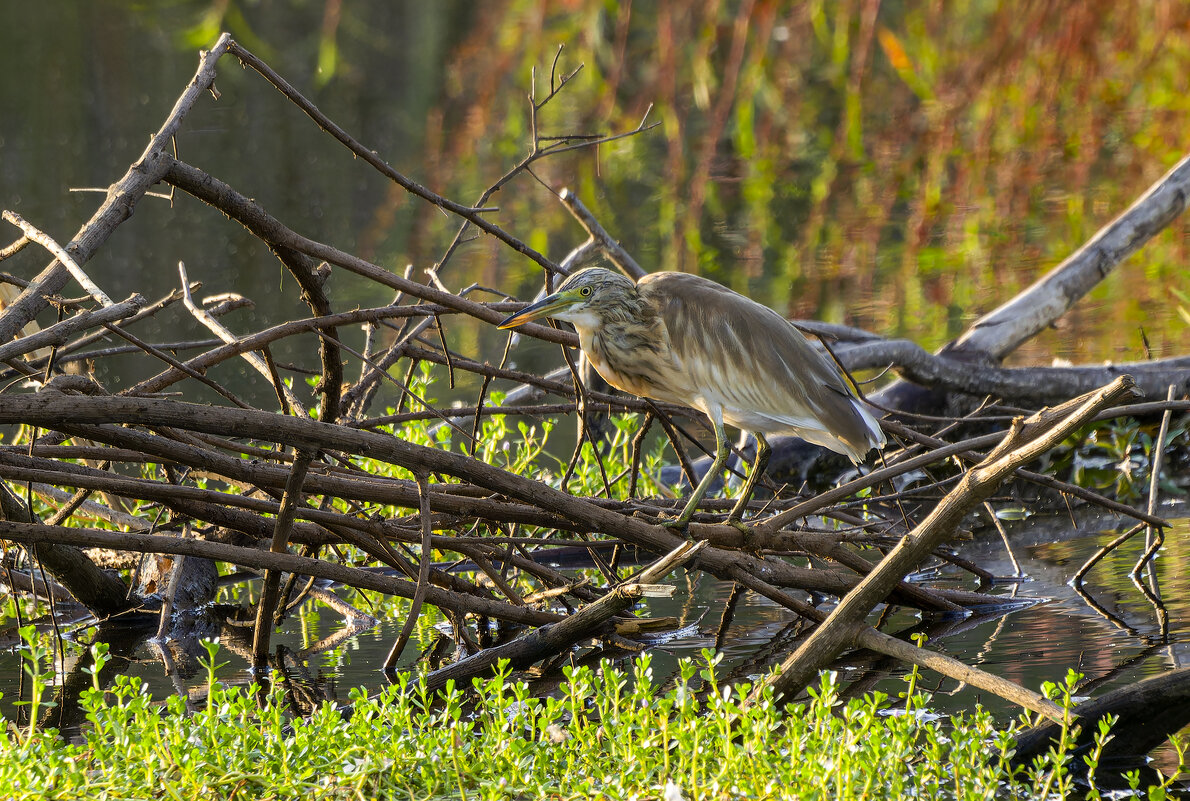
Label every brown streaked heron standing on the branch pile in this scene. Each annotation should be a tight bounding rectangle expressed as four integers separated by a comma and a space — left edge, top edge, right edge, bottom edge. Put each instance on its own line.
499, 267, 884, 527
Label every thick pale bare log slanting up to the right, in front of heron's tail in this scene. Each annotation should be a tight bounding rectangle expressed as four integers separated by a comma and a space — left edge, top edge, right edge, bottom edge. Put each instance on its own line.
756, 376, 1134, 697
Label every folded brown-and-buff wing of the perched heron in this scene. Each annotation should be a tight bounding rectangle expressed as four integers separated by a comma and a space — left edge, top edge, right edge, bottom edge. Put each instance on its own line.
638, 273, 881, 458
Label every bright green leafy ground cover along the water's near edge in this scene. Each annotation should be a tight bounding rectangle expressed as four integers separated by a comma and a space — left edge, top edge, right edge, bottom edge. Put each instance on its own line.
0, 631, 1169, 799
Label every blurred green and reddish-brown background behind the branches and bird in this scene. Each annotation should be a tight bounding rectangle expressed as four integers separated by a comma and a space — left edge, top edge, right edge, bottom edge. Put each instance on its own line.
0, 0, 1190, 399
